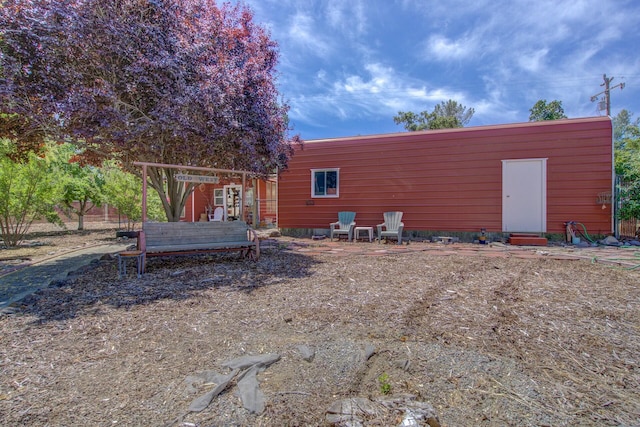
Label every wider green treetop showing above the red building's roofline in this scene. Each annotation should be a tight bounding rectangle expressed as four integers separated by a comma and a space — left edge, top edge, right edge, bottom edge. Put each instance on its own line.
393, 99, 475, 131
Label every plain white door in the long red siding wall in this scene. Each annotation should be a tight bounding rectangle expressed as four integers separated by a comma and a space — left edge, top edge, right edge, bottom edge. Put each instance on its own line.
502, 159, 547, 233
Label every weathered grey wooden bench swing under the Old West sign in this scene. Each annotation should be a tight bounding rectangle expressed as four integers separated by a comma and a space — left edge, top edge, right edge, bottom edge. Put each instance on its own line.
138, 221, 260, 260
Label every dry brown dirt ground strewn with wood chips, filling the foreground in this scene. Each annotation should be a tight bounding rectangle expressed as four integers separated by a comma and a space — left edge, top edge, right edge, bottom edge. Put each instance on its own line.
0, 226, 640, 427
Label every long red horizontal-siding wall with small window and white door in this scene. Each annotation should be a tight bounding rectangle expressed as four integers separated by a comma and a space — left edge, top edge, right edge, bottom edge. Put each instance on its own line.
278, 117, 613, 234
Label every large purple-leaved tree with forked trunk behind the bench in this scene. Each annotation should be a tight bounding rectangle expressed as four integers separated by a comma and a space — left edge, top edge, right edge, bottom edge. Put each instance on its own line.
0, 0, 300, 221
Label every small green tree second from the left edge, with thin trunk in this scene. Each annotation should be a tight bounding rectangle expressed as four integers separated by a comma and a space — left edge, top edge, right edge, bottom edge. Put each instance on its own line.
55, 144, 104, 230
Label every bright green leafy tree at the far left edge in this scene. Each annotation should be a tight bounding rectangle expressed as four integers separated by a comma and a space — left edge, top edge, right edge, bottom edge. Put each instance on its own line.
0, 139, 63, 246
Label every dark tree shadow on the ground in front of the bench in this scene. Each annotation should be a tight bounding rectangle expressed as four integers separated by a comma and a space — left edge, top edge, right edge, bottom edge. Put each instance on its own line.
17, 248, 319, 323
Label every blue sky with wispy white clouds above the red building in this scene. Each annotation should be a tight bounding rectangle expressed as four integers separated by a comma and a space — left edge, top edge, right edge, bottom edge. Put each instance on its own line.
235, 0, 640, 140
